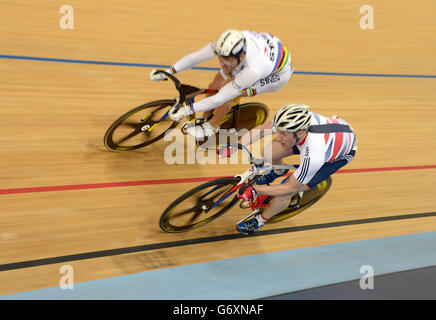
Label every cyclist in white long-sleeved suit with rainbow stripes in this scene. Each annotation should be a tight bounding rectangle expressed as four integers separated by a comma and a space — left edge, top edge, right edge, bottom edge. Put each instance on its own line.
150, 29, 293, 140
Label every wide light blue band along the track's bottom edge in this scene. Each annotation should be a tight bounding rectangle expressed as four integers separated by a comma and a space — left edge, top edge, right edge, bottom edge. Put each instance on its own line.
0, 232, 436, 300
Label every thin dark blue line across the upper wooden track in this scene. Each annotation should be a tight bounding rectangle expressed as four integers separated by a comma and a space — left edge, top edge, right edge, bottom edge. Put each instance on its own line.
0, 55, 436, 79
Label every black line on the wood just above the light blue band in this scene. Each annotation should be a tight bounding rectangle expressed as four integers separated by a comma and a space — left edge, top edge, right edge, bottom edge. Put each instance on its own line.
0, 212, 436, 271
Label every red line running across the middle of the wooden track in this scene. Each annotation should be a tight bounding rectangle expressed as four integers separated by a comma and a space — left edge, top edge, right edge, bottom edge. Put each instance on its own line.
0, 165, 436, 195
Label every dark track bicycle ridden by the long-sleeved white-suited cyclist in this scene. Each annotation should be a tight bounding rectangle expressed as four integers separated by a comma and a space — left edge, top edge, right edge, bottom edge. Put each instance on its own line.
103, 70, 269, 152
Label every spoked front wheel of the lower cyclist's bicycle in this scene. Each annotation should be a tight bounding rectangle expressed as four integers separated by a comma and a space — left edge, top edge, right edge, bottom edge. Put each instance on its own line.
159, 177, 240, 232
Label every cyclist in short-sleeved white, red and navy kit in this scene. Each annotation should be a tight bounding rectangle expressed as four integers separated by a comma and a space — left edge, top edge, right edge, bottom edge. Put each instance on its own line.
218, 104, 357, 234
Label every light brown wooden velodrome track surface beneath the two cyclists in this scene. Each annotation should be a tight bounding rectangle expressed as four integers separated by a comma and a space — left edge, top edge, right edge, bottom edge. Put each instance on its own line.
0, 0, 436, 294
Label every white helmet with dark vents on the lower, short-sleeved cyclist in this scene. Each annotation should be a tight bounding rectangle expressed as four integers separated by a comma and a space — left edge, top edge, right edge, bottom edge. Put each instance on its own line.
273, 104, 312, 132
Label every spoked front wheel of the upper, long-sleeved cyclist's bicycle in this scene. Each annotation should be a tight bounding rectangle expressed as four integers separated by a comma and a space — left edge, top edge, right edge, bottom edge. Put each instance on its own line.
104, 100, 178, 152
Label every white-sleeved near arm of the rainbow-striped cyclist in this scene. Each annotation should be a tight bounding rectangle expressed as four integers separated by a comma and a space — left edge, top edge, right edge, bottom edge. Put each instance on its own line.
191, 67, 259, 112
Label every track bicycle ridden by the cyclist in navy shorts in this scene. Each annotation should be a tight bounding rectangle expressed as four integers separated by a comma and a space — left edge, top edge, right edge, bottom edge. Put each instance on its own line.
159, 144, 332, 233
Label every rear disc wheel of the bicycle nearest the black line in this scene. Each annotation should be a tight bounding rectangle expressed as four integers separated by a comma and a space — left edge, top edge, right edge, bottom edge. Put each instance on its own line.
267, 177, 332, 223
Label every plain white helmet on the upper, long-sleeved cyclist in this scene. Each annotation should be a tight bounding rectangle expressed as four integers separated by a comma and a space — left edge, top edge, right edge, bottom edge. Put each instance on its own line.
214, 29, 247, 62
